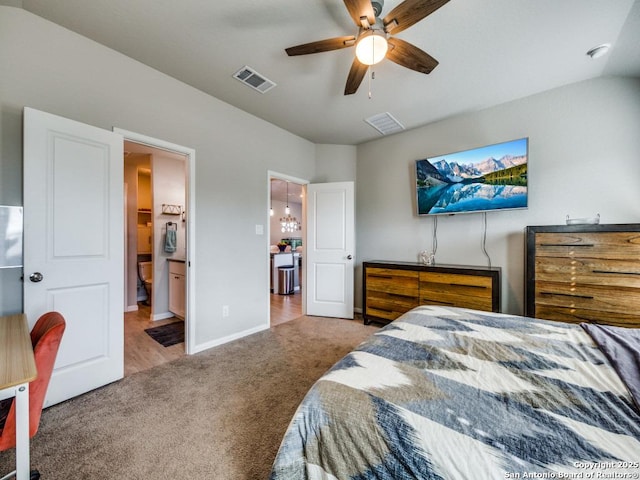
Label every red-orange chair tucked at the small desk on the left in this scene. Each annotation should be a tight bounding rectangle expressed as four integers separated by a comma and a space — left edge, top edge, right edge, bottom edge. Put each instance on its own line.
0, 312, 66, 479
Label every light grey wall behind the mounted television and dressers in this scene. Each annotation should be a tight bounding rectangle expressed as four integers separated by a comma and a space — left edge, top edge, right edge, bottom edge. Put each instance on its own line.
356, 78, 640, 314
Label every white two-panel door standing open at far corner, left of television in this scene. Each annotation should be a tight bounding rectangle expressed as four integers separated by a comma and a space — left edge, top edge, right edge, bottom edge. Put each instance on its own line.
305, 182, 355, 318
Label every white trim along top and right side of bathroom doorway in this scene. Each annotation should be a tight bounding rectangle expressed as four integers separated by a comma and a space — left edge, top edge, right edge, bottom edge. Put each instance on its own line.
113, 127, 196, 355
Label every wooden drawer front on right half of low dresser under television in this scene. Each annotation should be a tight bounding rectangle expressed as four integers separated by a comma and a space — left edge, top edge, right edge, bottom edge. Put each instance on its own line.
420, 272, 493, 311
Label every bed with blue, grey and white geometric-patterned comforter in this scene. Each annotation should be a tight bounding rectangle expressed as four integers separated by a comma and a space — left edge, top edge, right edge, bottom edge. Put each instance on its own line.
270, 306, 640, 480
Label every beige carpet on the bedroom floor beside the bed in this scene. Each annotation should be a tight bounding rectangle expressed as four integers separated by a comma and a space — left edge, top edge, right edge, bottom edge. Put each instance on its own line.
0, 317, 377, 480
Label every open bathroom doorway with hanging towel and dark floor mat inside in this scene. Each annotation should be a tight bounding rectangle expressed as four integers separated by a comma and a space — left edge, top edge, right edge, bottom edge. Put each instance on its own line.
119, 132, 195, 376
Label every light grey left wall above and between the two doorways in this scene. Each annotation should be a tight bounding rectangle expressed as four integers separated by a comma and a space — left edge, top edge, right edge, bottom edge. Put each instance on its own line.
0, 7, 315, 348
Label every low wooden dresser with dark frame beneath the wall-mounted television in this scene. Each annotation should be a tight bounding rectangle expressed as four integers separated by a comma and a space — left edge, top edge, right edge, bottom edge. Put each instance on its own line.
362, 261, 501, 324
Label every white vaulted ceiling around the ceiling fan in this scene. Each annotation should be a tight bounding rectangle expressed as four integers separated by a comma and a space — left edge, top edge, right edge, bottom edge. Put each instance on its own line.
8, 0, 640, 145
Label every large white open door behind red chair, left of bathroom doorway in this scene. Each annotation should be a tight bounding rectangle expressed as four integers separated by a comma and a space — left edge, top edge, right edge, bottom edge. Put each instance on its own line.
24, 108, 124, 406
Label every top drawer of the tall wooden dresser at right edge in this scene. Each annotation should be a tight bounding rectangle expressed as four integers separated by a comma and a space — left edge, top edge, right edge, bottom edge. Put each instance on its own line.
535, 232, 640, 260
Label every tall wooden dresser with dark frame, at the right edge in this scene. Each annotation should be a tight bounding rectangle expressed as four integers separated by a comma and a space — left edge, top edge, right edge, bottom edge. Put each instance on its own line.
525, 224, 640, 328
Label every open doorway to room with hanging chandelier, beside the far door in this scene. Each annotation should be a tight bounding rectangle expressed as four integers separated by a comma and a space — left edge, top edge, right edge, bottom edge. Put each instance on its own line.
269, 174, 306, 326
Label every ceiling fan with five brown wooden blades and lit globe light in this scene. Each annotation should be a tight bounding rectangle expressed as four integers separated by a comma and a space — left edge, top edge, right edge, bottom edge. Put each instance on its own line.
285, 0, 449, 95
